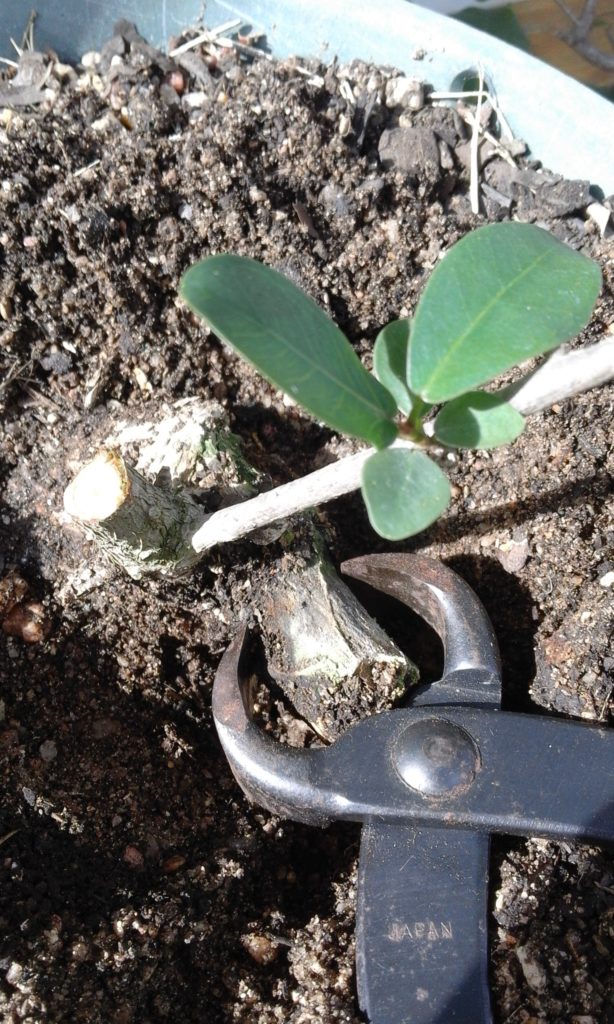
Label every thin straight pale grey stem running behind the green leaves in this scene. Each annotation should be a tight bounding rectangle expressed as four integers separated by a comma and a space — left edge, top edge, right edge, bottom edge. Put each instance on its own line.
191, 337, 614, 554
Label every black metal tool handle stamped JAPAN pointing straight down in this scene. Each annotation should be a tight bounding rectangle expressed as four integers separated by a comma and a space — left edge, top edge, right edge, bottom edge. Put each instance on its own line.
356, 821, 492, 1024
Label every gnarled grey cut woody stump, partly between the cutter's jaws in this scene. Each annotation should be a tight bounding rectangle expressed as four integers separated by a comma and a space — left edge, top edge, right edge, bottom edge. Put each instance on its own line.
64, 399, 416, 741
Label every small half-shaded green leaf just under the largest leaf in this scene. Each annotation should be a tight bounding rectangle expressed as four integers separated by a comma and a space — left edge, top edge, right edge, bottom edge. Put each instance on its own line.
435, 391, 525, 449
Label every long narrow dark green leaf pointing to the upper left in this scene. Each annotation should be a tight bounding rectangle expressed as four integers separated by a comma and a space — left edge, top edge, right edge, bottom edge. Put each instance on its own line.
180, 254, 397, 447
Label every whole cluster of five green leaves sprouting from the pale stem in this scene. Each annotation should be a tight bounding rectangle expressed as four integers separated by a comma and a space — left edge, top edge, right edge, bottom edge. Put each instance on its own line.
181, 223, 601, 541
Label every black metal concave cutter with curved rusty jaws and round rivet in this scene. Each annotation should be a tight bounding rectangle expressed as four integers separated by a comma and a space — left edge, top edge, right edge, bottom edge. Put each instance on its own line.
213, 554, 614, 1024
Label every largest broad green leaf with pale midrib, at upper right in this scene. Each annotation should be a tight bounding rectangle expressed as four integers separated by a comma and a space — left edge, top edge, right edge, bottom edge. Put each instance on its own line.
407, 223, 601, 402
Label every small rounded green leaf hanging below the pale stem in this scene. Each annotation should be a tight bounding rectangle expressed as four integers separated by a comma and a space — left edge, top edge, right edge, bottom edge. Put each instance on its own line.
362, 447, 450, 541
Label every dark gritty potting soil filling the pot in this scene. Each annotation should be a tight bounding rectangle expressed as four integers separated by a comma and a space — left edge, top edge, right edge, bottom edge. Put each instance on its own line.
0, 22, 614, 1024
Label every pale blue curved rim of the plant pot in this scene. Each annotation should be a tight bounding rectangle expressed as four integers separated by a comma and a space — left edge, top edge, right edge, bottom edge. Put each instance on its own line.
0, 0, 614, 196
